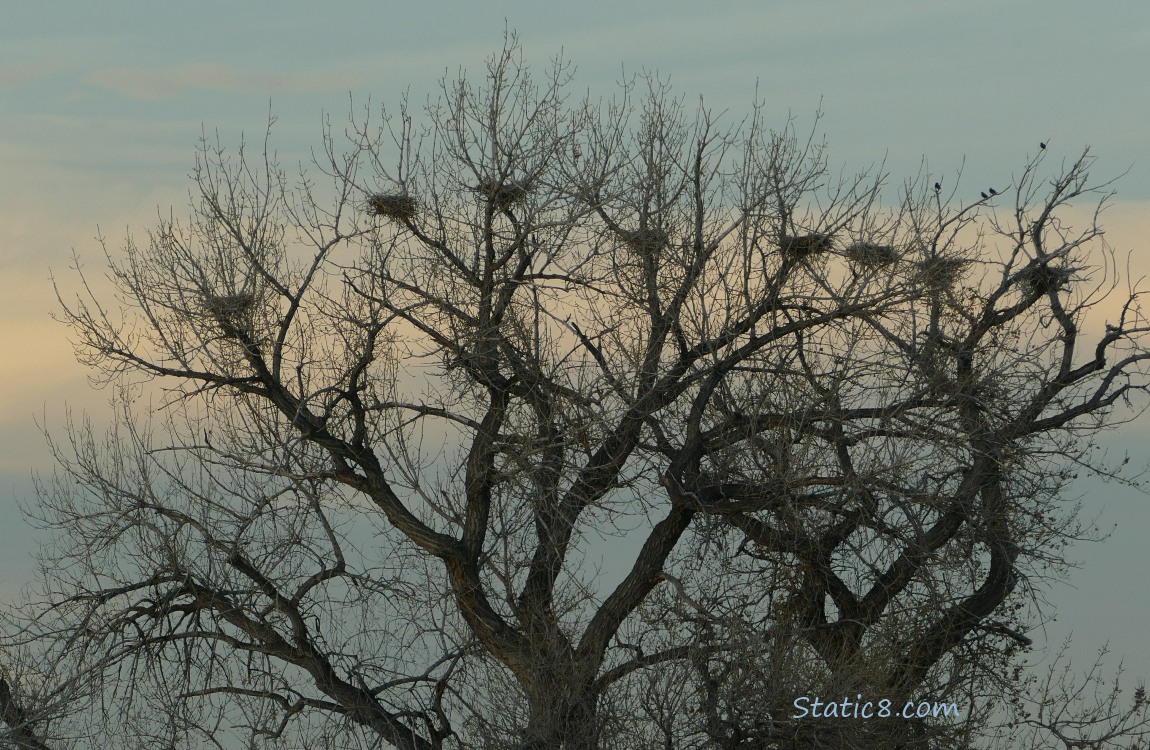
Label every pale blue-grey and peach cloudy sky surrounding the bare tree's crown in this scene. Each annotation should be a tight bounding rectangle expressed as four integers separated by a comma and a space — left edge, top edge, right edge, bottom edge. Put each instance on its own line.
0, 0, 1150, 703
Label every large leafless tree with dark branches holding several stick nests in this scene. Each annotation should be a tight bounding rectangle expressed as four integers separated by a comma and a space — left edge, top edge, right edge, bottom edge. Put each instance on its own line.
5, 37, 1150, 750
